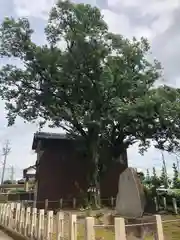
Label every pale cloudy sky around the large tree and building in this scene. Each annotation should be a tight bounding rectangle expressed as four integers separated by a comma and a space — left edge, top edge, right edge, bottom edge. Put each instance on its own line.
0, 0, 180, 178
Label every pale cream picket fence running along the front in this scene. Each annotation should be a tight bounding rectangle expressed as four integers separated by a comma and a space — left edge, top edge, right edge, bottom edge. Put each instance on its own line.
0, 203, 164, 240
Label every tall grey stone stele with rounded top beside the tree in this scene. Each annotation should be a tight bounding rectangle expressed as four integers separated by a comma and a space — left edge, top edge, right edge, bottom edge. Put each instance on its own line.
116, 168, 146, 218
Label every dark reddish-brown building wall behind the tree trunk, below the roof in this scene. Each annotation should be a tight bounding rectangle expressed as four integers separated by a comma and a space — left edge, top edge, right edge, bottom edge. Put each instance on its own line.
37, 142, 127, 208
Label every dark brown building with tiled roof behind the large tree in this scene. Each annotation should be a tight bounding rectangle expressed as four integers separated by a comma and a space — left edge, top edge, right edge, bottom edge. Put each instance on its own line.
32, 132, 127, 208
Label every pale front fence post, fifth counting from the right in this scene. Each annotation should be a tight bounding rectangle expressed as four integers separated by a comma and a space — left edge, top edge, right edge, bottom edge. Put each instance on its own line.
56, 212, 64, 240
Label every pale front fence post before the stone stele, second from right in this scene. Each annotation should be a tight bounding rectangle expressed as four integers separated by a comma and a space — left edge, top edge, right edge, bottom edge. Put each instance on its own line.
115, 217, 126, 240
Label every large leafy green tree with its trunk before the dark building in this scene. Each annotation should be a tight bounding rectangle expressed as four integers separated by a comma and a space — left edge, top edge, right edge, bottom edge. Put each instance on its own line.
0, 1, 180, 204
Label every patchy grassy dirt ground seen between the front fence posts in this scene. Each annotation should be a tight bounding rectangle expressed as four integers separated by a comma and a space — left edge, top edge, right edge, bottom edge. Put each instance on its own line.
56, 209, 180, 240
